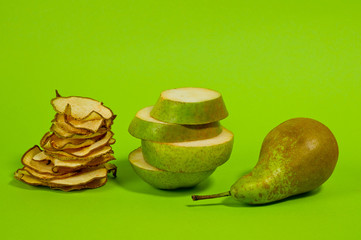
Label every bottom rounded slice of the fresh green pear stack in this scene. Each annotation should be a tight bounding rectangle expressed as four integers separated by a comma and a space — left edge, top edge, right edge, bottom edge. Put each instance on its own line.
129, 148, 215, 189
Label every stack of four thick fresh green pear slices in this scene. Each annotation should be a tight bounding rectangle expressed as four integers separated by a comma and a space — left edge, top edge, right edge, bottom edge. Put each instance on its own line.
128, 88, 233, 189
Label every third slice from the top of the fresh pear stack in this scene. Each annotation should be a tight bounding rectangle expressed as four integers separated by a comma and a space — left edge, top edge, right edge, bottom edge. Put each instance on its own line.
142, 128, 233, 172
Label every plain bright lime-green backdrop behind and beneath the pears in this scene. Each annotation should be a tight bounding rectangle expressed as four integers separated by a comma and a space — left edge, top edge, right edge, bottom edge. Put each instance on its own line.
0, 0, 361, 239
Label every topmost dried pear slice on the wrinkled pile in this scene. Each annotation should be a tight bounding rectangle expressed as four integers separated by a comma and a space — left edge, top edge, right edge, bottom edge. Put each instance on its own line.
51, 97, 113, 120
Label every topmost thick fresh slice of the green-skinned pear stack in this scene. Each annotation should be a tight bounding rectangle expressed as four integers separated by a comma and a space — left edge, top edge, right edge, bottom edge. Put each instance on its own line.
150, 88, 228, 125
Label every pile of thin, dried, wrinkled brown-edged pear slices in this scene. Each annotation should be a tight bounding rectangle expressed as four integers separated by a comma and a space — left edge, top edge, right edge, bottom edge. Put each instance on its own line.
15, 92, 116, 191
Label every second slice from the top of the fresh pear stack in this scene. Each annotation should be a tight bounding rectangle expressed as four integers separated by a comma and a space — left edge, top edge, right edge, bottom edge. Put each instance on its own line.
128, 106, 222, 142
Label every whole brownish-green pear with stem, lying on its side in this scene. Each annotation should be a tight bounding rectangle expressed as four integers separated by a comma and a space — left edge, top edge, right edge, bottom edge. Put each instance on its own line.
192, 118, 338, 204
